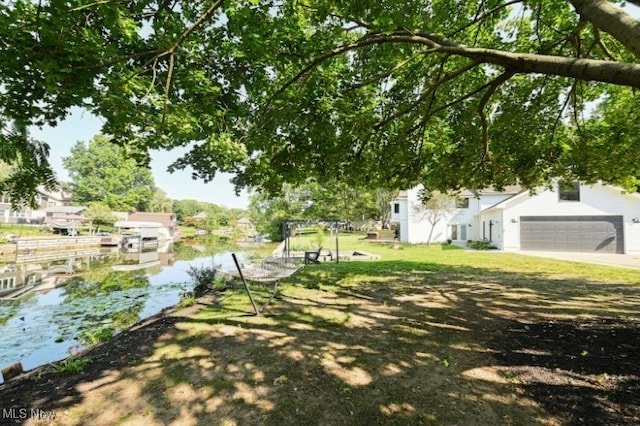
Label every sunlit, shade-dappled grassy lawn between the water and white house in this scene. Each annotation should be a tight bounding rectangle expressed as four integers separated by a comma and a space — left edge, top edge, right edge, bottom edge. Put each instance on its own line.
11, 237, 640, 425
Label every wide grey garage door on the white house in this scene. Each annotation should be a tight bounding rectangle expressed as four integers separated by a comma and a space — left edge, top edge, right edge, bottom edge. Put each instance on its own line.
520, 216, 624, 253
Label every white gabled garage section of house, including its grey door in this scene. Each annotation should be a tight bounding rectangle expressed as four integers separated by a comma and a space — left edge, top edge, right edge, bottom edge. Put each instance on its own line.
476, 183, 640, 254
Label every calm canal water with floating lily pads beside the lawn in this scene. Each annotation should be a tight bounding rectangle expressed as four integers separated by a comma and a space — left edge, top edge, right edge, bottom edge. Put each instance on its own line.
0, 243, 255, 383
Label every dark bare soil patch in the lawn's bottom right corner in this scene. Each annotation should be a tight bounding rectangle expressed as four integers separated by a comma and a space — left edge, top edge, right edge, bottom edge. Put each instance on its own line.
492, 318, 640, 425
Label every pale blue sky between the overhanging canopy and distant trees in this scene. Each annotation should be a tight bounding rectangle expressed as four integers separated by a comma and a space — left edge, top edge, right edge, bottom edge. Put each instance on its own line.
30, 108, 249, 209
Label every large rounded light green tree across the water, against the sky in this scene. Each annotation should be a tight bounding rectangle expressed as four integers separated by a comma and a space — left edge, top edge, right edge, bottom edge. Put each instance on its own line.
62, 136, 155, 211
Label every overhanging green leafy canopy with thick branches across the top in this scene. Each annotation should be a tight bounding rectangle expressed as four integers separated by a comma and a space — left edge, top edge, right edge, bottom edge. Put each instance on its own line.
0, 0, 640, 196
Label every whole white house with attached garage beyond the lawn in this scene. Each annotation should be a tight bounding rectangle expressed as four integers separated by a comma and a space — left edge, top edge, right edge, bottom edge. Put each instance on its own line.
391, 182, 640, 254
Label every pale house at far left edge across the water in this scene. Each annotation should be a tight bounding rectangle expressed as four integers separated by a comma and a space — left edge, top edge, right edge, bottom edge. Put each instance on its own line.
0, 186, 71, 224
